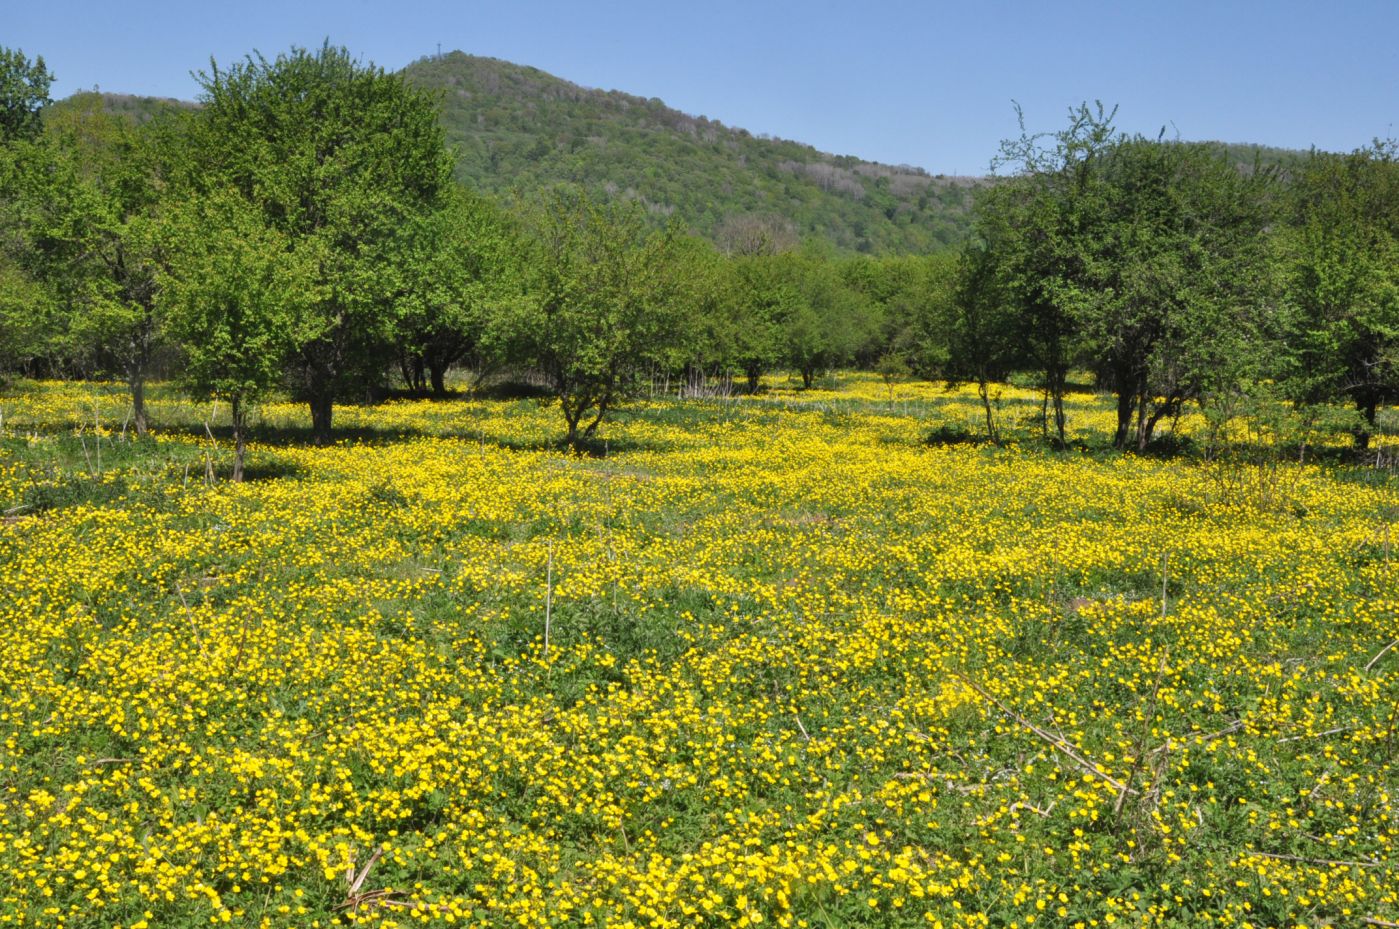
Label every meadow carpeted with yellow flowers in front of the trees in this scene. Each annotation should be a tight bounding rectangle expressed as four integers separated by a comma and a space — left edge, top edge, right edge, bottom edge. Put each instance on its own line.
0, 375, 1399, 929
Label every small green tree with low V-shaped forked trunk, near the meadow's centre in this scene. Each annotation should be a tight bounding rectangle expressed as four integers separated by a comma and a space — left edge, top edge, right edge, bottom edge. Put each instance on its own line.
504, 190, 677, 451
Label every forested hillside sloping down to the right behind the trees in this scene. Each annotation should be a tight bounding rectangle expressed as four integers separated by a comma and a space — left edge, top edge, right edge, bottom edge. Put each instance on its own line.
404, 52, 981, 253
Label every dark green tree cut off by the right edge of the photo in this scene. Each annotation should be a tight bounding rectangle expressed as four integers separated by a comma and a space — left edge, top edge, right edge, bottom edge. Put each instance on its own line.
1286, 143, 1399, 448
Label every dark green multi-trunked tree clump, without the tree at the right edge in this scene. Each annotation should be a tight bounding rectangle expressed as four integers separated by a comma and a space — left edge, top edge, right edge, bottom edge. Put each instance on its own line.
960, 105, 1283, 449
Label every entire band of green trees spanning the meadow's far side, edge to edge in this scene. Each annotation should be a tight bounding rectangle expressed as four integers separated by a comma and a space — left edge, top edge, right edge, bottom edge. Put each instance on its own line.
0, 45, 1399, 474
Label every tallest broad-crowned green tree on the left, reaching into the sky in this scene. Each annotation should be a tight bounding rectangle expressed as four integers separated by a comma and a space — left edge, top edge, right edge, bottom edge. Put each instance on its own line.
190, 43, 452, 442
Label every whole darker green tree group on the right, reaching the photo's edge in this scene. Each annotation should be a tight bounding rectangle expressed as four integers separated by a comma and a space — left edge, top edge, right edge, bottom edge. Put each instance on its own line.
943, 105, 1399, 448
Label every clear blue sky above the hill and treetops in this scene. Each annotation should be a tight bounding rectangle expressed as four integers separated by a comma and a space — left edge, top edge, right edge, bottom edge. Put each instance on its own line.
0, 0, 1399, 173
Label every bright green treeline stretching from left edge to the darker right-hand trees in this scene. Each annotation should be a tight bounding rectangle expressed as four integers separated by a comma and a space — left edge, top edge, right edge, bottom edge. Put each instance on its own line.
0, 46, 950, 475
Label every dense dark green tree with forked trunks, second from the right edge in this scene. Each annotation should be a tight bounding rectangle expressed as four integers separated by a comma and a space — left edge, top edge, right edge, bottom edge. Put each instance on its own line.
1073, 137, 1279, 449
